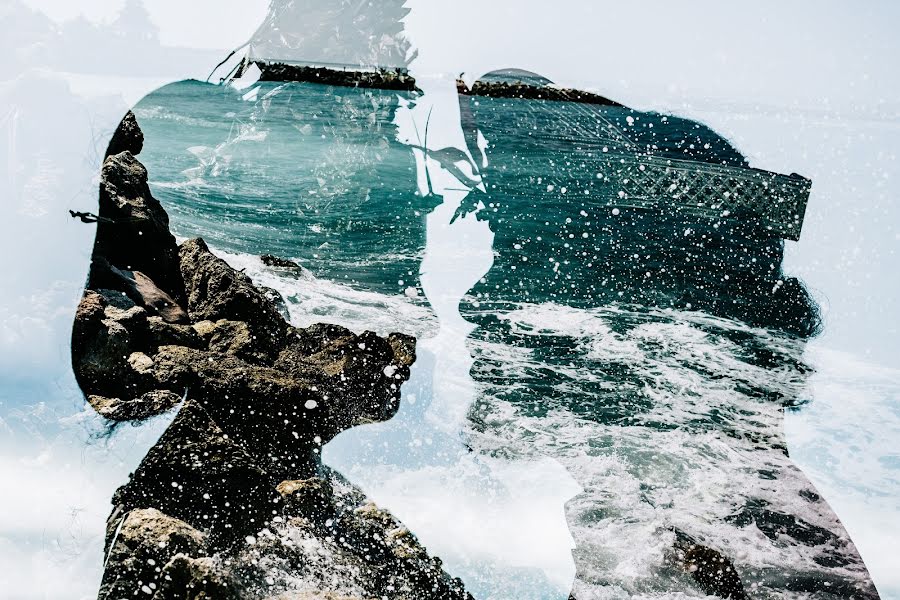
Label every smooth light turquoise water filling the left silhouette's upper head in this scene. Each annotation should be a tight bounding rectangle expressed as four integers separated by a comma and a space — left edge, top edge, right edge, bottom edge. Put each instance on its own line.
136, 81, 428, 293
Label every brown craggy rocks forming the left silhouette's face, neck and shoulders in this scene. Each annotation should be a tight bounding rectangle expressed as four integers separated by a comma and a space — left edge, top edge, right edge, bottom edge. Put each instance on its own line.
72, 113, 471, 600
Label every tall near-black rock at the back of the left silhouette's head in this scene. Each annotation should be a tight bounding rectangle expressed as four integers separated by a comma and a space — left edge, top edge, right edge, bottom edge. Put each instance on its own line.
89, 151, 184, 303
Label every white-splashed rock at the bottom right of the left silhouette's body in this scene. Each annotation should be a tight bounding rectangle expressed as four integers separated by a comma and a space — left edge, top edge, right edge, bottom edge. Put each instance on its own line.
234, 468, 471, 600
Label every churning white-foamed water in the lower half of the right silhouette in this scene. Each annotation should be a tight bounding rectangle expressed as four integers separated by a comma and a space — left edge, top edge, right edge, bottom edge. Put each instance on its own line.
458, 303, 866, 599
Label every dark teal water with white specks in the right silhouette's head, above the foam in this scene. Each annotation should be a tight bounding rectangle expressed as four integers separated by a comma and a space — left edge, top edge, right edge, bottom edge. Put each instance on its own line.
460, 74, 822, 338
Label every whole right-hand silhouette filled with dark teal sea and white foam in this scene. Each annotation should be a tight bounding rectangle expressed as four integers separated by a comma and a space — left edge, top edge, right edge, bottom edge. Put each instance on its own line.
460, 71, 877, 599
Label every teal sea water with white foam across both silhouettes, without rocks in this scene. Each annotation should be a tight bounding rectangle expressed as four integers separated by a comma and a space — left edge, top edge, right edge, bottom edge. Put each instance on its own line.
135, 82, 880, 600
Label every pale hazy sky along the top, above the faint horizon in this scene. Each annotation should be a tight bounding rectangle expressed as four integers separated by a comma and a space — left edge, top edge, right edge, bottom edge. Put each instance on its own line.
19, 0, 900, 116
